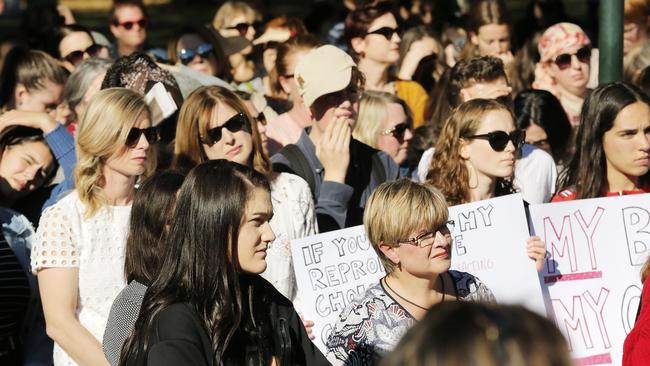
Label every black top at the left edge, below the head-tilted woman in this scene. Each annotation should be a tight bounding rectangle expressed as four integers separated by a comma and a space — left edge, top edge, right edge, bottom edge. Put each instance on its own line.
0, 234, 31, 339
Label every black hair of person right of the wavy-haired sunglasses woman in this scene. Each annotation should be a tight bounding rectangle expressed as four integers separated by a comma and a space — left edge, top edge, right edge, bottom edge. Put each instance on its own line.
515, 89, 573, 163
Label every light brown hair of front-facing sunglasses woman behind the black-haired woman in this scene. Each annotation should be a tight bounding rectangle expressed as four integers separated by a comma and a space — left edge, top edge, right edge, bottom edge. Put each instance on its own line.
172, 85, 272, 177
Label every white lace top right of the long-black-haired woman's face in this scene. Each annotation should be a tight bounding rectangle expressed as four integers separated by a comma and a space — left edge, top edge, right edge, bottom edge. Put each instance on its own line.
262, 173, 318, 308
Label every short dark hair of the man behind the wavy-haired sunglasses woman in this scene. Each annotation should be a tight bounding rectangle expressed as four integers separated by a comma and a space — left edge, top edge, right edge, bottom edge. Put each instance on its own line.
447, 56, 508, 108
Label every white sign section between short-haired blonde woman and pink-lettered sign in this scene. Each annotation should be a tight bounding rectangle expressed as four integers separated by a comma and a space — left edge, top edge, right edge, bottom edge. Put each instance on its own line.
449, 194, 546, 314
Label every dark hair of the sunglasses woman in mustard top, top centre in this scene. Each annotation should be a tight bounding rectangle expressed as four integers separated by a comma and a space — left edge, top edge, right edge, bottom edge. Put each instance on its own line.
343, 0, 397, 61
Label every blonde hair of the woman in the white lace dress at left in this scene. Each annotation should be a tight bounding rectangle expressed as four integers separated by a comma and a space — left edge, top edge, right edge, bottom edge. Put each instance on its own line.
74, 88, 156, 218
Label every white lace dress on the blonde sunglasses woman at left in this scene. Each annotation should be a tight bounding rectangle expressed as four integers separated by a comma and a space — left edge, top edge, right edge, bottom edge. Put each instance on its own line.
31, 191, 131, 366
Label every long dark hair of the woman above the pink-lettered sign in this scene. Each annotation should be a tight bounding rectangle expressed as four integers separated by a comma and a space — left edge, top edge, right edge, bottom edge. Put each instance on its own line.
558, 82, 650, 199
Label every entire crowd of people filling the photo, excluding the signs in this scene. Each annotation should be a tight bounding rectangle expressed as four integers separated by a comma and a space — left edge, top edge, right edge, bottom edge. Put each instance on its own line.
0, 0, 650, 366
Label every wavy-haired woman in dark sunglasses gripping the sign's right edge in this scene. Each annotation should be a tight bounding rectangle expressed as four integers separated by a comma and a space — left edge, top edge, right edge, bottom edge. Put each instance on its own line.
427, 99, 546, 271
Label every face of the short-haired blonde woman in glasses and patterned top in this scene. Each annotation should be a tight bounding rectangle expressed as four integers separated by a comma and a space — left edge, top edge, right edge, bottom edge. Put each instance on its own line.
393, 226, 452, 278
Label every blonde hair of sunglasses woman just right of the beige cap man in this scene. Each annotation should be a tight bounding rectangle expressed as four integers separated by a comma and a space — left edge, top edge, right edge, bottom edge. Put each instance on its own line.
352, 91, 411, 148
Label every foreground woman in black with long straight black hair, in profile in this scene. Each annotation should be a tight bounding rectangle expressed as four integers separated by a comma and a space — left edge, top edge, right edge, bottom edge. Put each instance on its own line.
121, 160, 327, 365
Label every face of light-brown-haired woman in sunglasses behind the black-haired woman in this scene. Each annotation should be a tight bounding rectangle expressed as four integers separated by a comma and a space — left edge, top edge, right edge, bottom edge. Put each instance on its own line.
201, 102, 253, 165
